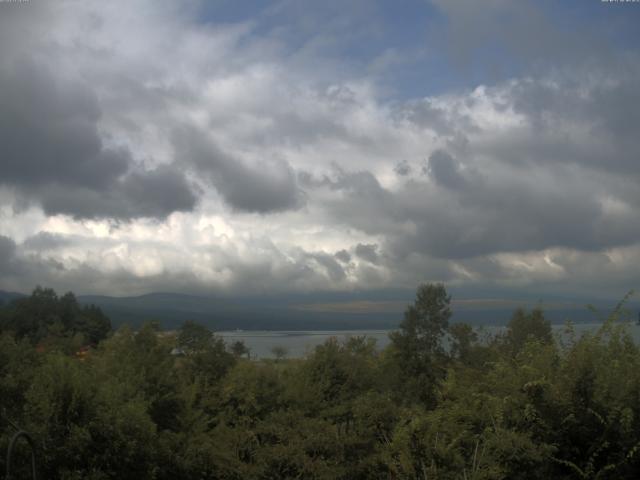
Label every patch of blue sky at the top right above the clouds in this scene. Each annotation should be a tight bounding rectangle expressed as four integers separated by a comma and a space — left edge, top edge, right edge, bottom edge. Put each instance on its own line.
194, 0, 640, 101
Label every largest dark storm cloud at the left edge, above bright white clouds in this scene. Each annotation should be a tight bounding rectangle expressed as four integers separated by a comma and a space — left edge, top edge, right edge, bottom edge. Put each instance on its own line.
0, 62, 196, 219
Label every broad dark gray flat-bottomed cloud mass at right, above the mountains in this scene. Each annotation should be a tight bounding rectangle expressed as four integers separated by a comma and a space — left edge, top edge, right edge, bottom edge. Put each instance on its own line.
327, 131, 640, 259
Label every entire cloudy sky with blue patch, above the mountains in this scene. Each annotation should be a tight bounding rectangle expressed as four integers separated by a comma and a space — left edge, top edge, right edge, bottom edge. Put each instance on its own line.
0, 0, 640, 298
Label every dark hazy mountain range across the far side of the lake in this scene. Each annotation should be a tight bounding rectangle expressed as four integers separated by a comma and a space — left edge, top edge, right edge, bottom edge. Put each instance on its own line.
0, 290, 640, 331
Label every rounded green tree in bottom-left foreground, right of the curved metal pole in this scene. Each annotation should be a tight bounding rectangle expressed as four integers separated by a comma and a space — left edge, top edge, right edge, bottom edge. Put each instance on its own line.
23, 354, 156, 479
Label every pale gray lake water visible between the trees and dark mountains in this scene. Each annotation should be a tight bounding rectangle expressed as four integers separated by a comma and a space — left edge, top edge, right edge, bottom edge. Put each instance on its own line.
216, 323, 640, 358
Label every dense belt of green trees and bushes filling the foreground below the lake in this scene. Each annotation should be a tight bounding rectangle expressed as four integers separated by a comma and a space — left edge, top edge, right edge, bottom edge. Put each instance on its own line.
0, 284, 640, 480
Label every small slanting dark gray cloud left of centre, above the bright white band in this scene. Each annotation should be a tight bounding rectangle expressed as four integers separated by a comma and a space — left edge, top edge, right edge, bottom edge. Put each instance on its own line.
174, 128, 303, 213
